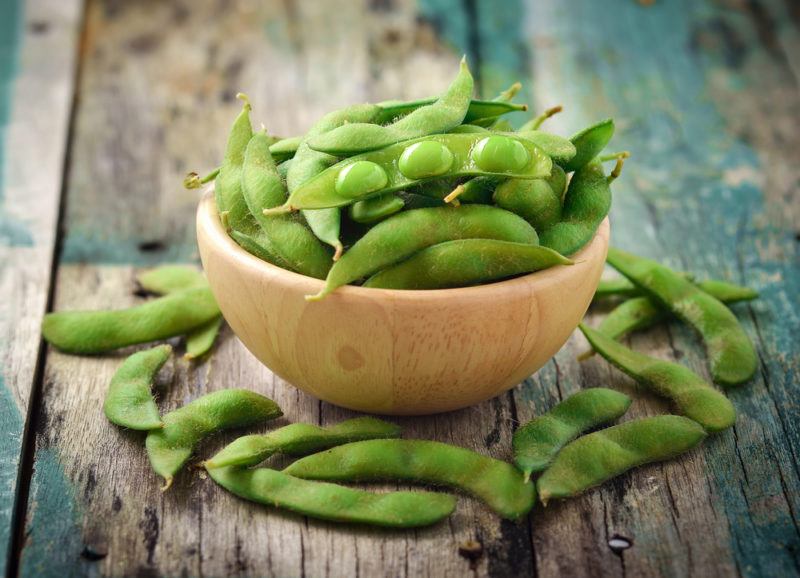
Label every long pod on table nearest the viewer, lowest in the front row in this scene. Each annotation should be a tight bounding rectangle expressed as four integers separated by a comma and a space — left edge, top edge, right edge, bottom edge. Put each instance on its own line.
208, 467, 456, 528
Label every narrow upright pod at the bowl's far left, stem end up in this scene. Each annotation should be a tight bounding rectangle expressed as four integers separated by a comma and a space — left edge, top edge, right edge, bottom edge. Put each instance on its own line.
214, 94, 253, 229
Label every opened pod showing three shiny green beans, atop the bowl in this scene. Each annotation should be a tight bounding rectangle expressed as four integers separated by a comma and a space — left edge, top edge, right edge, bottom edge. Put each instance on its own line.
268, 133, 552, 213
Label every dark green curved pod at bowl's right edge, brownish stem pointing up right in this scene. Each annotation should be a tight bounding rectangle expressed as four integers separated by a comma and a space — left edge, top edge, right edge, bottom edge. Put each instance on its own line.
541, 159, 623, 255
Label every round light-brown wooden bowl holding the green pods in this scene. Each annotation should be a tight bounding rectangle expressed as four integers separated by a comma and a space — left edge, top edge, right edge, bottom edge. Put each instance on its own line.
197, 195, 609, 415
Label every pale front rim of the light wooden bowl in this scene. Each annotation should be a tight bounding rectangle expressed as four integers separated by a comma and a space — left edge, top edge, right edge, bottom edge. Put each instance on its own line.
197, 188, 610, 301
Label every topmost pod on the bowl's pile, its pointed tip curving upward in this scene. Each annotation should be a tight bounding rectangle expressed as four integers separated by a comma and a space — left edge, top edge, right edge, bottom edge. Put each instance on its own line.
307, 59, 473, 156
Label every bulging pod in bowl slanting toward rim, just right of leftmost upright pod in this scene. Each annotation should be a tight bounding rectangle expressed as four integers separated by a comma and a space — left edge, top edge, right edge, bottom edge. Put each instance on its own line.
242, 132, 331, 279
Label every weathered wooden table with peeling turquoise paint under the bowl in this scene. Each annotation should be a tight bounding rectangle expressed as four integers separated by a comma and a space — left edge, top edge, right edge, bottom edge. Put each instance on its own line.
0, 0, 800, 577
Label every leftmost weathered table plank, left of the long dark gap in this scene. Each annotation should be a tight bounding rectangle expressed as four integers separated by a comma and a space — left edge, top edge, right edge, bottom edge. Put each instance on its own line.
0, 0, 81, 574
